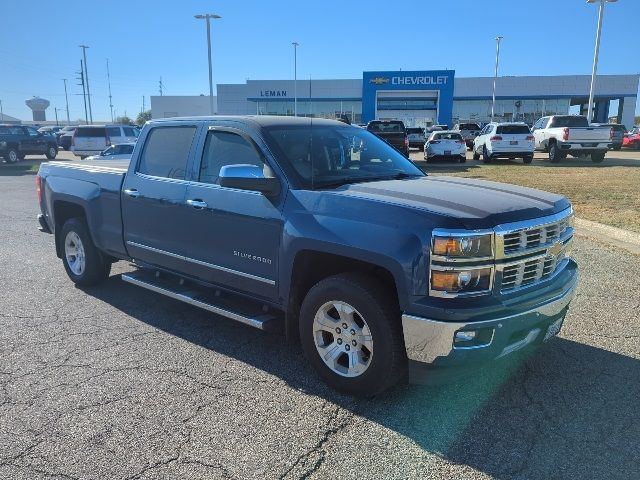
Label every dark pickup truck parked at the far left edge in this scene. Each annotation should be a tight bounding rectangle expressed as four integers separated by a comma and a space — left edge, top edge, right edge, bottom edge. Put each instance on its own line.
0, 125, 58, 163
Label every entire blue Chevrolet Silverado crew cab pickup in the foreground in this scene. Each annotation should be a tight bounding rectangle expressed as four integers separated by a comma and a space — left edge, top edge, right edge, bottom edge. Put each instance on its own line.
36, 116, 578, 396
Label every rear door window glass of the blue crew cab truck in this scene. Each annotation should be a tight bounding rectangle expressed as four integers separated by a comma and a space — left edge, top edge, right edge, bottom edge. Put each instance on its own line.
137, 127, 196, 180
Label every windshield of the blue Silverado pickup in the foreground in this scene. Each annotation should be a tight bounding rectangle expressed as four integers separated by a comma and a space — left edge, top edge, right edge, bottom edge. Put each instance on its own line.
264, 125, 424, 189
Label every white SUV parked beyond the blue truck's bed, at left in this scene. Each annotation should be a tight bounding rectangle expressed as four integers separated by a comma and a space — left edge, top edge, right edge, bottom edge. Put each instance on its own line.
71, 125, 139, 158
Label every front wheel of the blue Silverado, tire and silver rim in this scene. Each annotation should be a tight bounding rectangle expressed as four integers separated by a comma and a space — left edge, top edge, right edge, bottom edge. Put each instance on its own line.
299, 273, 407, 397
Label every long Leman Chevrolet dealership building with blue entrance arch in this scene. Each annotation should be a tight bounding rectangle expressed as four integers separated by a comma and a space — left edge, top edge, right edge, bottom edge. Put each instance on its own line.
151, 70, 640, 128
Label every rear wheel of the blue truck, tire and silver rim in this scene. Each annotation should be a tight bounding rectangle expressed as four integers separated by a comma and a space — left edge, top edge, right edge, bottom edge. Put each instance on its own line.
58, 218, 111, 286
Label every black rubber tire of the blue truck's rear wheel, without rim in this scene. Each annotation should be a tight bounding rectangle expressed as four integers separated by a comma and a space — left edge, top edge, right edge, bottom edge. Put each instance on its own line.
58, 218, 111, 286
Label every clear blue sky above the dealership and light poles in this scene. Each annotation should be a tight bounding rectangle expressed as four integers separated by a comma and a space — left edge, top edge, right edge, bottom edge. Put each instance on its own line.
0, 0, 640, 120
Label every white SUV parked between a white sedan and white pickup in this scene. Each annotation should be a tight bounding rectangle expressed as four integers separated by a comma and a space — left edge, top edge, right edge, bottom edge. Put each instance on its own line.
473, 122, 535, 163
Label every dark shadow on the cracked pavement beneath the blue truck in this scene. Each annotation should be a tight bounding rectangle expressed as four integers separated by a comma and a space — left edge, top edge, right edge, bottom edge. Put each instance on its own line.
85, 276, 640, 479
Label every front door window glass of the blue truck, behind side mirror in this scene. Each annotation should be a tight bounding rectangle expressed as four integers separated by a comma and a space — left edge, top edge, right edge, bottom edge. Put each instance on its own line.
198, 131, 265, 183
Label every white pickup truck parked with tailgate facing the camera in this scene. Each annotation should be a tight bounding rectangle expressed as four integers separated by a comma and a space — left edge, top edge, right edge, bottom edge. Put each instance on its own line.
532, 115, 612, 163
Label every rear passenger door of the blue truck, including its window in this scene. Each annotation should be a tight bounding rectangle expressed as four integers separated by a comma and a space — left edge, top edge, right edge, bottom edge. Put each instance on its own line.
121, 122, 198, 272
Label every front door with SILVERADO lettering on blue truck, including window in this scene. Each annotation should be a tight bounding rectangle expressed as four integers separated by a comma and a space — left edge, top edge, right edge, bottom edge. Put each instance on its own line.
183, 127, 283, 299
